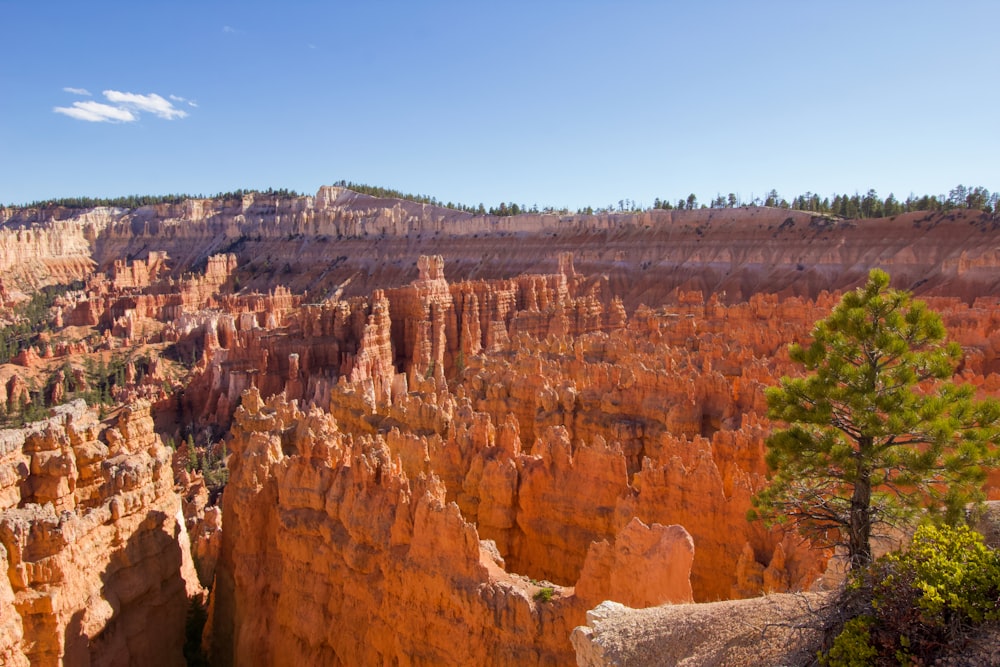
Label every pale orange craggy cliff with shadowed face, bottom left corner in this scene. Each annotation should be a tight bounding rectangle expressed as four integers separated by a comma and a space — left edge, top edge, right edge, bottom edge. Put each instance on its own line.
0, 401, 198, 665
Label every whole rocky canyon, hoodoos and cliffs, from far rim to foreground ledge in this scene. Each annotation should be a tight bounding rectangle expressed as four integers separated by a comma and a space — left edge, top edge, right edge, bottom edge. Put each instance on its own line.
0, 187, 1000, 665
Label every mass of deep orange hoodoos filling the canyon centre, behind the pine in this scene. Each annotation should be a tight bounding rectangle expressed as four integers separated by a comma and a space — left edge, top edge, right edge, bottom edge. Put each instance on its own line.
197, 257, 1000, 664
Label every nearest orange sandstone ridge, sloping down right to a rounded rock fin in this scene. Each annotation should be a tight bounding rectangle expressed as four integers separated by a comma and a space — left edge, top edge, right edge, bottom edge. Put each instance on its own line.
211, 389, 692, 665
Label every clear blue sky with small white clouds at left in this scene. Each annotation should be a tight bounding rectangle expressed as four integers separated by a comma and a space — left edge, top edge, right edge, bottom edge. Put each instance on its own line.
0, 0, 1000, 208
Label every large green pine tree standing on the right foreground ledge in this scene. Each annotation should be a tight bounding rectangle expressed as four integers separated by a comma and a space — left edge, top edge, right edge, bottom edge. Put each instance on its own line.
750, 269, 1000, 568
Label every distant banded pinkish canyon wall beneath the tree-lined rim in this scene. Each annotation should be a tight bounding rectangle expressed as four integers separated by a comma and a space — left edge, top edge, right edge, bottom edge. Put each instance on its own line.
0, 187, 1000, 312
